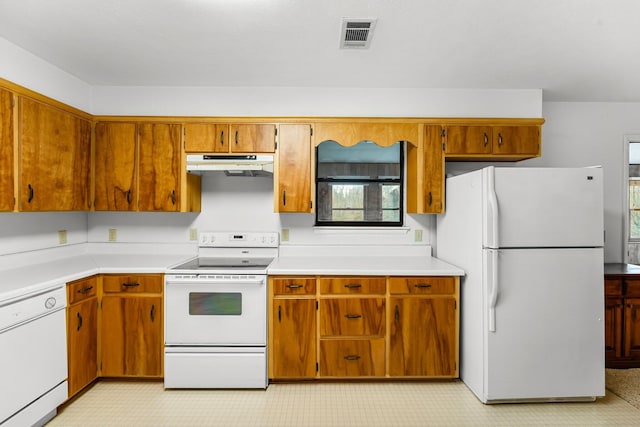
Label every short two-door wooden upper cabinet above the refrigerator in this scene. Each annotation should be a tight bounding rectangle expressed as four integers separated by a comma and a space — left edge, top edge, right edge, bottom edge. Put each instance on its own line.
445, 125, 540, 161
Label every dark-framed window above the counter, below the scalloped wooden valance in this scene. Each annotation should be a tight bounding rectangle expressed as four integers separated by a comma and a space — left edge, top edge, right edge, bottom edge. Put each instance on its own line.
316, 141, 403, 226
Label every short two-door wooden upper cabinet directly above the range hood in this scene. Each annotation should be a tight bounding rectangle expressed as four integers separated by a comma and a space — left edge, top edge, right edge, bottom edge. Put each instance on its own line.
184, 123, 276, 154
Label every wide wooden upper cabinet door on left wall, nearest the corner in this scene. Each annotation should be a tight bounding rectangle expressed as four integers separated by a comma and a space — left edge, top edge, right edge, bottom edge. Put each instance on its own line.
19, 98, 91, 211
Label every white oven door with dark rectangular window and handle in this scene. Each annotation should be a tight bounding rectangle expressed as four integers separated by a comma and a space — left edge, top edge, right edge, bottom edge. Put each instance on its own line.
164, 275, 267, 346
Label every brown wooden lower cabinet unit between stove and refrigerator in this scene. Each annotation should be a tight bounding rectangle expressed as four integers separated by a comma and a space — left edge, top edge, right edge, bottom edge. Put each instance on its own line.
269, 276, 460, 380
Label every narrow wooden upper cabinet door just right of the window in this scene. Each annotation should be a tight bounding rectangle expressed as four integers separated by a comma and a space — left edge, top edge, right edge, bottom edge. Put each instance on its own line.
424, 126, 444, 213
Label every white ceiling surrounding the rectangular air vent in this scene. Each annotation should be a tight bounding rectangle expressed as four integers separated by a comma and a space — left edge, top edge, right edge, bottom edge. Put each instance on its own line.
0, 0, 640, 102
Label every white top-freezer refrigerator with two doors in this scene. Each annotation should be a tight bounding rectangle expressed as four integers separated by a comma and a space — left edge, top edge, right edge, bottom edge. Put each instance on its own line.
436, 167, 605, 403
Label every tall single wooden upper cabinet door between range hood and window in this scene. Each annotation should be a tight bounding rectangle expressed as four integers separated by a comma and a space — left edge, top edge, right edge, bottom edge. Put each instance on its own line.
275, 124, 311, 212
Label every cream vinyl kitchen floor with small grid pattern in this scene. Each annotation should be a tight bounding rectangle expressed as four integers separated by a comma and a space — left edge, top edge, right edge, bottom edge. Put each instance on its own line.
47, 381, 640, 427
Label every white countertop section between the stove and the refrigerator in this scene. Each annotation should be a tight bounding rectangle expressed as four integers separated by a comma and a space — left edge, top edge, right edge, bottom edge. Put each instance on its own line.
268, 256, 464, 276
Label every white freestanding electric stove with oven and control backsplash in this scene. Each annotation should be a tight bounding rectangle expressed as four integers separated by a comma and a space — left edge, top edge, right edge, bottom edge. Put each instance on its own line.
164, 232, 278, 389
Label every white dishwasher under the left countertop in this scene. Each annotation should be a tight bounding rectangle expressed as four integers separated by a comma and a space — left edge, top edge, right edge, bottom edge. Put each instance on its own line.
0, 284, 67, 427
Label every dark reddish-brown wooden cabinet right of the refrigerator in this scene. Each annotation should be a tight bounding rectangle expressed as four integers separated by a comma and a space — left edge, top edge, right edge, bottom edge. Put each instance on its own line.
605, 269, 640, 368
